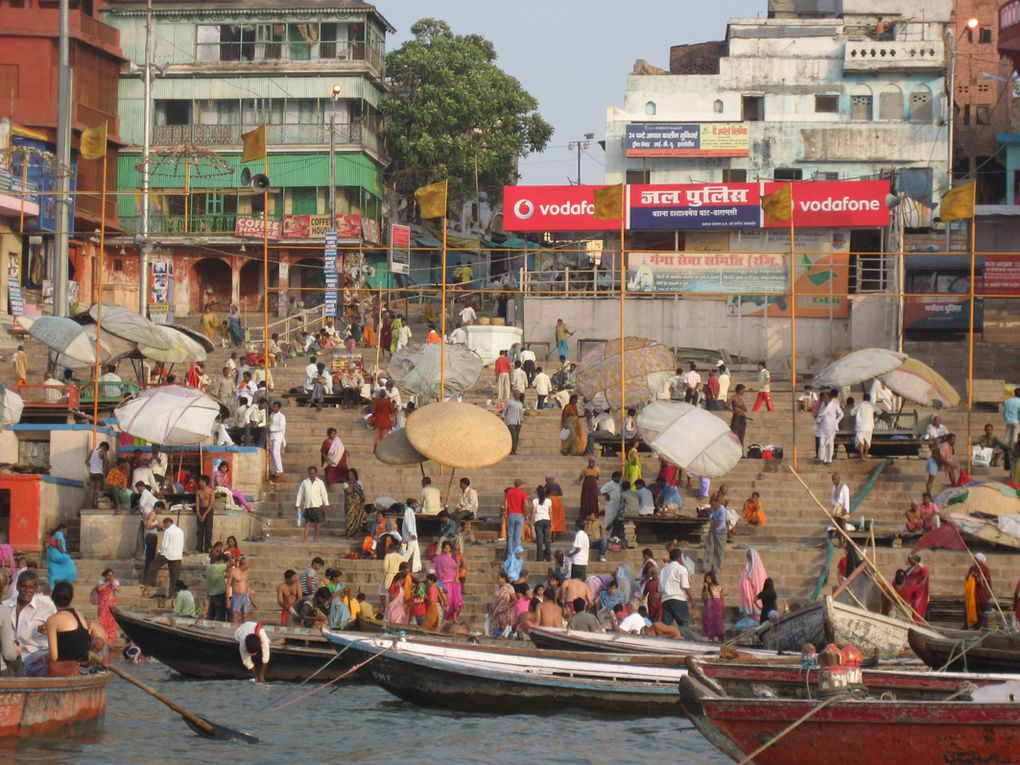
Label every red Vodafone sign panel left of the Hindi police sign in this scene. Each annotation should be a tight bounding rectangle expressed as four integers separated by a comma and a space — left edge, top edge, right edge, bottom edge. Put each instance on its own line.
503, 186, 620, 232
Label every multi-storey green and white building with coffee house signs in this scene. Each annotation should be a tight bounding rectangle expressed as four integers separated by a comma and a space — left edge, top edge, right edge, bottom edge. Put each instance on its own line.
103, 0, 393, 313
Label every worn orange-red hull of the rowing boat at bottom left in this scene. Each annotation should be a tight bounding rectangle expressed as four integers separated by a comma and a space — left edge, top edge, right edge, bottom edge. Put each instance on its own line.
0, 672, 112, 738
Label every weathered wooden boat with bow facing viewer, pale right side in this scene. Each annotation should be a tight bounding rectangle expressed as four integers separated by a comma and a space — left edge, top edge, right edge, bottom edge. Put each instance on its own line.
759, 596, 934, 660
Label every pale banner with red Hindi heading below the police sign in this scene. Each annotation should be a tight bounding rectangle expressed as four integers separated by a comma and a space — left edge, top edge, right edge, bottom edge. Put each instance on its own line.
627, 252, 789, 295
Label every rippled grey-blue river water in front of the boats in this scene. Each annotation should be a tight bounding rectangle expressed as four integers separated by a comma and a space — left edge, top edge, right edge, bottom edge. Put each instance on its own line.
0, 662, 729, 765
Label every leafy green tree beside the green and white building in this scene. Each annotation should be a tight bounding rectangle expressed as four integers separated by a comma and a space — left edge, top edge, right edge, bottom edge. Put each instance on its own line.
383, 18, 553, 213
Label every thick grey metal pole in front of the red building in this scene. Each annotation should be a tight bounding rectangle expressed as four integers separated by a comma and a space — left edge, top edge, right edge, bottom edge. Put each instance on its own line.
50, 0, 72, 316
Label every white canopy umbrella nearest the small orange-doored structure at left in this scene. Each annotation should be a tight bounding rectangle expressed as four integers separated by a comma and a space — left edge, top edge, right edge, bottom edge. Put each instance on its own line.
113, 386, 219, 446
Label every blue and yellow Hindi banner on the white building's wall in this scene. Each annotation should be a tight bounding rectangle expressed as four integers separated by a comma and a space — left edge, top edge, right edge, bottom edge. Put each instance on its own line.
623, 122, 751, 157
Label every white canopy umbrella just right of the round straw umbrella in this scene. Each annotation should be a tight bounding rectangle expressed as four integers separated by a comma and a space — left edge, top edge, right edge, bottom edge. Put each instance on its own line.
638, 402, 744, 477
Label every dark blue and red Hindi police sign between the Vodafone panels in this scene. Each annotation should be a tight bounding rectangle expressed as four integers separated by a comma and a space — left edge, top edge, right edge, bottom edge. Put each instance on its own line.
627, 184, 762, 231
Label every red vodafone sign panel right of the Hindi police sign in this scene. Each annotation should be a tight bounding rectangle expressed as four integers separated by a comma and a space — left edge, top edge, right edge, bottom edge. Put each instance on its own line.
764, 181, 889, 228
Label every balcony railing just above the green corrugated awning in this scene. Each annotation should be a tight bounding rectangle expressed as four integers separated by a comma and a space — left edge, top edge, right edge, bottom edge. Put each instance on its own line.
152, 121, 381, 153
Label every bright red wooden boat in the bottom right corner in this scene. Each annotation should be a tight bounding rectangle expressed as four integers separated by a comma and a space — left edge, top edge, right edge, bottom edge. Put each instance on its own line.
679, 669, 1020, 765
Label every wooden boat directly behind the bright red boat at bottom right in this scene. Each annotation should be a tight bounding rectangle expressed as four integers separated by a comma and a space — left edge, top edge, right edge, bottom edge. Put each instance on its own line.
698, 659, 1020, 701
